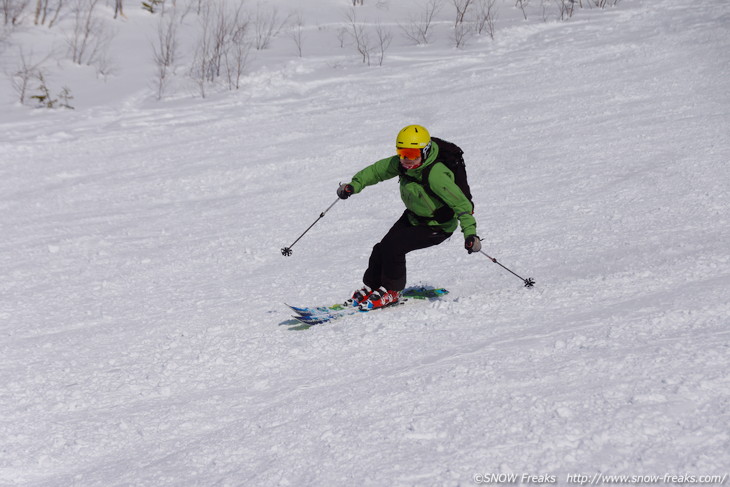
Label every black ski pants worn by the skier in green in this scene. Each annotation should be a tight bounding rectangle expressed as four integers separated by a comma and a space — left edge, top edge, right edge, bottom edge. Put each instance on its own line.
363, 212, 451, 291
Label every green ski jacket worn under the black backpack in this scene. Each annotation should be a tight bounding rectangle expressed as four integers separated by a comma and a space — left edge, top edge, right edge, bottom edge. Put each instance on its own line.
350, 142, 477, 238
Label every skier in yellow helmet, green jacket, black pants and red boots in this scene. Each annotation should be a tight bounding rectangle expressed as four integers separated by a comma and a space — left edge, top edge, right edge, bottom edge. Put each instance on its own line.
337, 125, 482, 309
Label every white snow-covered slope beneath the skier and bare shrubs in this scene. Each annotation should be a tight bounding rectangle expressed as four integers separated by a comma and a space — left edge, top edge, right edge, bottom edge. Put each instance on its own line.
0, 0, 730, 486
